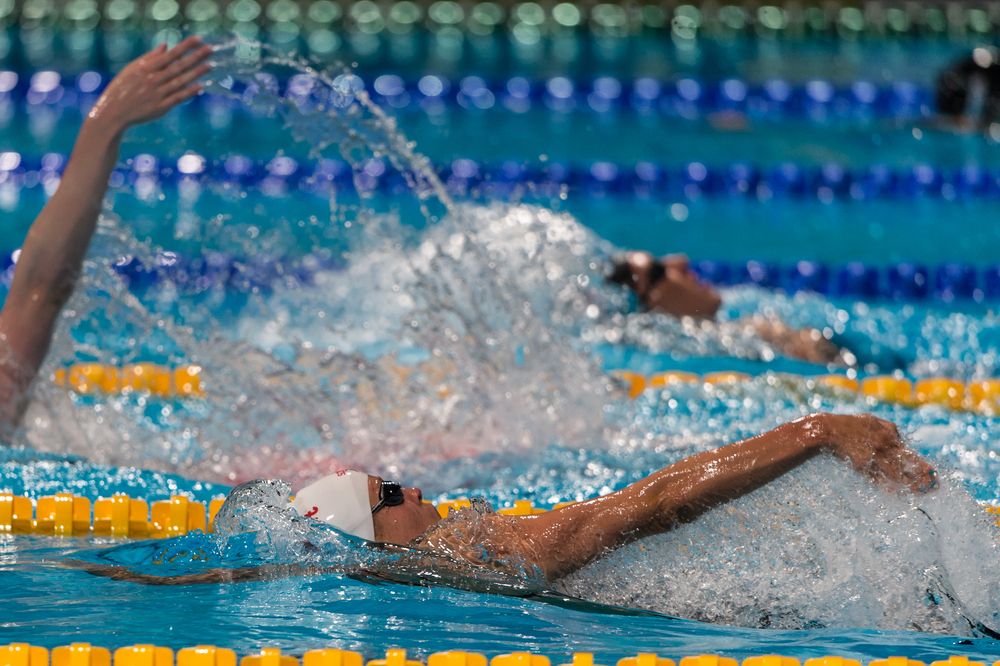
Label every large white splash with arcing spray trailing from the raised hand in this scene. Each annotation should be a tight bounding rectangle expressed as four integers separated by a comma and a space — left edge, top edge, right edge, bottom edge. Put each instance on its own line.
7, 43, 609, 480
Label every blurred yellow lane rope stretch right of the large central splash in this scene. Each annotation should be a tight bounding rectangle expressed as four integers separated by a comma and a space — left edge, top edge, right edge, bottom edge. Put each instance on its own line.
616, 371, 1000, 415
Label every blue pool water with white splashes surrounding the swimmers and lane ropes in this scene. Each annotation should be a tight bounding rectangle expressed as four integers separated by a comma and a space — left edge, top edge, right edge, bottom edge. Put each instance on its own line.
0, 31, 1000, 663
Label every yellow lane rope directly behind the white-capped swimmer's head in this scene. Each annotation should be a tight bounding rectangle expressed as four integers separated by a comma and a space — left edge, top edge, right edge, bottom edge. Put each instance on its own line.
0, 492, 1000, 536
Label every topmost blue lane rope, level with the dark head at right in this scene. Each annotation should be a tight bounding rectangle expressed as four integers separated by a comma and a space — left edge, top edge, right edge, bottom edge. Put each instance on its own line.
0, 70, 934, 121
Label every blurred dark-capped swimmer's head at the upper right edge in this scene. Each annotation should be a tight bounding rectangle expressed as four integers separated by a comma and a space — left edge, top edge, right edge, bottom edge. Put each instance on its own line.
935, 46, 1000, 130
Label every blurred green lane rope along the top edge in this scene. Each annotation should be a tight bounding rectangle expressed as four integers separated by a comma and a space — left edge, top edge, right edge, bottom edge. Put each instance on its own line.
0, 0, 1000, 39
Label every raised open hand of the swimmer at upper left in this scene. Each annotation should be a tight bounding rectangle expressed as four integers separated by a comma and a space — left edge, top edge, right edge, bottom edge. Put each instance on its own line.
87, 37, 212, 133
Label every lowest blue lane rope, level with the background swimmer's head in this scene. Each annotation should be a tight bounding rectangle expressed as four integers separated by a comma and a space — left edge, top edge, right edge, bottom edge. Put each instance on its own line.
0, 252, 1000, 302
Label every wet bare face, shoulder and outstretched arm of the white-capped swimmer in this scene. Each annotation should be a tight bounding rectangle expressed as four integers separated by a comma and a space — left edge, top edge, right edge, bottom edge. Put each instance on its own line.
369, 414, 936, 581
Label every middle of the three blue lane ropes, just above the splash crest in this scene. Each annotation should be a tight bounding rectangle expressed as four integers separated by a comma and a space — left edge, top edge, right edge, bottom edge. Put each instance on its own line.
0, 151, 1000, 202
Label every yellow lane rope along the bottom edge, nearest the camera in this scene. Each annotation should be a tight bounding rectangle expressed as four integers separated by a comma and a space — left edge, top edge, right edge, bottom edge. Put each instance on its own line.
0, 643, 1000, 666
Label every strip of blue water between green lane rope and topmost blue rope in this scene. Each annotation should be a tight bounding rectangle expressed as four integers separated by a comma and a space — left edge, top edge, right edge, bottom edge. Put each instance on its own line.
0, 31, 978, 84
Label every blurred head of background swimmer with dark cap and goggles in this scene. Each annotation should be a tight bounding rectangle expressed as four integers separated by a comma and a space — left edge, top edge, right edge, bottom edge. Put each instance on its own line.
626, 252, 722, 319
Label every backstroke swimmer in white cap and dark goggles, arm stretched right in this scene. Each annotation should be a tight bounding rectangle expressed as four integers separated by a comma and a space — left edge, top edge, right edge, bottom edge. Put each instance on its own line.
76, 414, 936, 585
